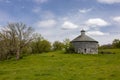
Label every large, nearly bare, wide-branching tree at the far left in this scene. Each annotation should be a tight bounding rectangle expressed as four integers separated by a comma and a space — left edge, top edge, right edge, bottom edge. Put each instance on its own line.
0, 23, 33, 60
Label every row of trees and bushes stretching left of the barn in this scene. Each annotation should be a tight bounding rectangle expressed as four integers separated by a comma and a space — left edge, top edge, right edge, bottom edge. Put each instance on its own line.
0, 23, 73, 60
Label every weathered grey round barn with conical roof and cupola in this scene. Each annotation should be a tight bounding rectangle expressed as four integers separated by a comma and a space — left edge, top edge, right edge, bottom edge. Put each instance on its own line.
71, 30, 98, 54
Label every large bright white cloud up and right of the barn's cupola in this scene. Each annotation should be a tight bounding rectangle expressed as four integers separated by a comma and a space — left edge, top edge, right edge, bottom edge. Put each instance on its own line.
85, 18, 109, 27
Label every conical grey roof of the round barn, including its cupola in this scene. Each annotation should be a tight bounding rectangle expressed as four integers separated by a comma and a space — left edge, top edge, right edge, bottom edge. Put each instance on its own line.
71, 30, 98, 42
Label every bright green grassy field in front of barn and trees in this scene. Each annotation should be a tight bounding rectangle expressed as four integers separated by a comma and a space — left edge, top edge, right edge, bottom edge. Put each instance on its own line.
0, 49, 120, 80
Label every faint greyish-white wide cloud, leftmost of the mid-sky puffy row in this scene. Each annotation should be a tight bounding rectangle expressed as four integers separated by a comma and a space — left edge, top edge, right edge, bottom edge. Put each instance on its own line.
35, 19, 57, 28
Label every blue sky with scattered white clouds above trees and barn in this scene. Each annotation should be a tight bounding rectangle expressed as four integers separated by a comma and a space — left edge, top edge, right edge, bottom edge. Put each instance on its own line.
0, 0, 120, 45
